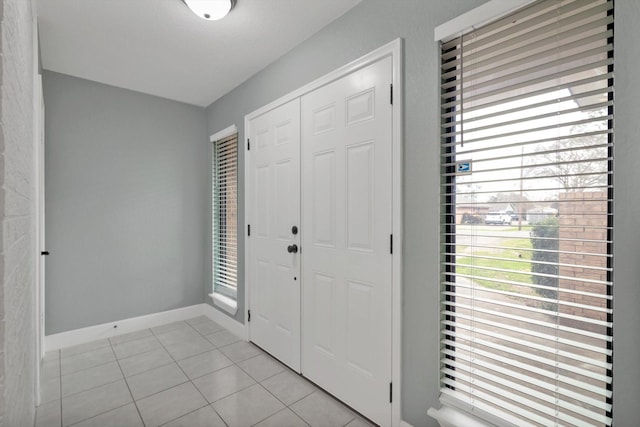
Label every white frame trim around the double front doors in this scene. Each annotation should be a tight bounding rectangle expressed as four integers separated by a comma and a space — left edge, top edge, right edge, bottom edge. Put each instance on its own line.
243, 38, 404, 427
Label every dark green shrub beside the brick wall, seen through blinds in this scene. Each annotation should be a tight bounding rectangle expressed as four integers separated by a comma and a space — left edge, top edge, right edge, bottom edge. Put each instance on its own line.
531, 217, 559, 298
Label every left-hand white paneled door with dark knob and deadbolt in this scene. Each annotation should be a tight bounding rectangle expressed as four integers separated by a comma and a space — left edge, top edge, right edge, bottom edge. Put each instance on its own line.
246, 99, 301, 372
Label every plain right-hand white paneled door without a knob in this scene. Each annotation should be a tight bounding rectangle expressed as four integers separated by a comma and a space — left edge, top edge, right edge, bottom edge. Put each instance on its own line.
302, 57, 392, 425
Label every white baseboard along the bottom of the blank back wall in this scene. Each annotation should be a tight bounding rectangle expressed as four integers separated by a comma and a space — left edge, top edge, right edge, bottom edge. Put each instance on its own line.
44, 304, 205, 351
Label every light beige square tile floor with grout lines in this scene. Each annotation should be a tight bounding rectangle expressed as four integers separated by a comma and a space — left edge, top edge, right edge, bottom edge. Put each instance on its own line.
36, 316, 372, 427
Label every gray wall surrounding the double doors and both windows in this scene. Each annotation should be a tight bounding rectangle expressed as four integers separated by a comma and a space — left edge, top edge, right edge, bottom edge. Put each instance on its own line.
207, 0, 640, 427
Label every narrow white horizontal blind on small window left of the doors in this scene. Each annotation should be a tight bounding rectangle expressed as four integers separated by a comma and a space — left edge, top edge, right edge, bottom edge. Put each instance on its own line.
212, 133, 238, 300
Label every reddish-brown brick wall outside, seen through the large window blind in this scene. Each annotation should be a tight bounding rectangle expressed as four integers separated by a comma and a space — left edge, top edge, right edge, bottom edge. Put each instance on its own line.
558, 191, 607, 331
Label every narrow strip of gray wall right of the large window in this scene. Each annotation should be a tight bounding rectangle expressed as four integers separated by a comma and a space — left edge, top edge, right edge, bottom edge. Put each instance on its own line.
613, 0, 640, 427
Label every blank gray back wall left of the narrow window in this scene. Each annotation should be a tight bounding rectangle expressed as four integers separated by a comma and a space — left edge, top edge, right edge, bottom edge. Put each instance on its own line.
44, 71, 210, 335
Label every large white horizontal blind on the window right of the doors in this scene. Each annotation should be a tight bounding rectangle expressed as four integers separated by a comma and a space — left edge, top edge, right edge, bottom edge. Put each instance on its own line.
441, 0, 613, 426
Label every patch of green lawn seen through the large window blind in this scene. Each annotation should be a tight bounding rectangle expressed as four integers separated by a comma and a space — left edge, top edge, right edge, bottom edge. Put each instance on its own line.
456, 239, 532, 292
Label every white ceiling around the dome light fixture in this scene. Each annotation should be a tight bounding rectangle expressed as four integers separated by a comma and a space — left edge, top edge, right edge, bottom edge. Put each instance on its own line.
37, 0, 361, 107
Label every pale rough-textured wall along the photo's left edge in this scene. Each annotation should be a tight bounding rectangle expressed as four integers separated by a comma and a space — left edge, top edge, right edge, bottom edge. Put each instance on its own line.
0, 0, 36, 427
